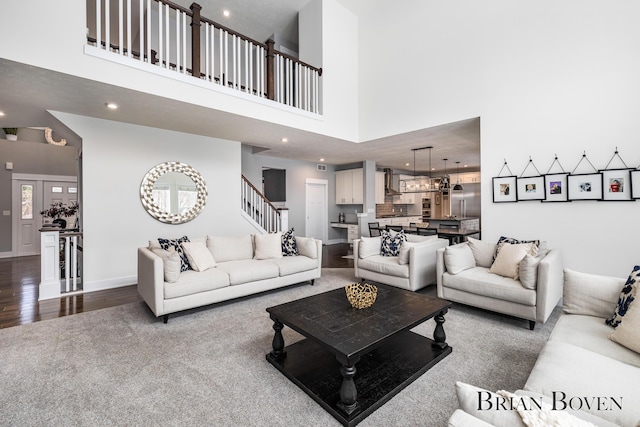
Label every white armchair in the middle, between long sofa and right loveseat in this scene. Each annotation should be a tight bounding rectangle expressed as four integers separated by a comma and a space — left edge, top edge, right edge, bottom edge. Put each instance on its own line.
353, 234, 449, 291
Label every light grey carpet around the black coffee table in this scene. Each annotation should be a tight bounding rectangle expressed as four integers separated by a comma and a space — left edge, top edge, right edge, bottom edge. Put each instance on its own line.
0, 269, 560, 427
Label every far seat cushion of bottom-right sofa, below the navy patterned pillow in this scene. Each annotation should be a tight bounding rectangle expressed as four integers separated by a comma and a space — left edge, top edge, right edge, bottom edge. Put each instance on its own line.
549, 314, 640, 367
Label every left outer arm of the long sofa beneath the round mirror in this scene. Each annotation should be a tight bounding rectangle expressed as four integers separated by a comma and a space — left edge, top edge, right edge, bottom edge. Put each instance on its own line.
137, 247, 165, 317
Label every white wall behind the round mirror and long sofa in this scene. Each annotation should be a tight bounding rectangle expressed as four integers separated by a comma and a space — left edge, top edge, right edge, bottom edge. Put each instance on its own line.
53, 112, 255, 290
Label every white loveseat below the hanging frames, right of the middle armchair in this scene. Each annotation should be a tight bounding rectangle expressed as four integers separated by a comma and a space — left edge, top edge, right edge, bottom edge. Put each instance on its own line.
436, 239, 563, 330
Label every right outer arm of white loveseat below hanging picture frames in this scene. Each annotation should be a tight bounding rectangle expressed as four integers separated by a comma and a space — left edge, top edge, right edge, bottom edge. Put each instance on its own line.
536, 249, 564, 323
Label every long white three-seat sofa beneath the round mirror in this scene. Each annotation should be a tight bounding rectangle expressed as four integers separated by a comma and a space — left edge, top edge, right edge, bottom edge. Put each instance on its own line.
138, 235, 322, 323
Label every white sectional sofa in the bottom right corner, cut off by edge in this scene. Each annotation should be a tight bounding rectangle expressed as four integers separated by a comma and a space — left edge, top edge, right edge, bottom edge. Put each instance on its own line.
449, 270, 640, 427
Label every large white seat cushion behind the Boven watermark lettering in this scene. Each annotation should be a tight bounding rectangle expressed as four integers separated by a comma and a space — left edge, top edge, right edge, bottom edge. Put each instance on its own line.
524, 341, 640, 426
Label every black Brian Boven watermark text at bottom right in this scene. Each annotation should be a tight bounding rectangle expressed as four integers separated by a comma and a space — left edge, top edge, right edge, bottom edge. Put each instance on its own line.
478, 391, 622, 411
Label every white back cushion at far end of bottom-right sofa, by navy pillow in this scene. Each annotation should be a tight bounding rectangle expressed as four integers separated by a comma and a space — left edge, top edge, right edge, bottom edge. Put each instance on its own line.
562, 268, 624, 319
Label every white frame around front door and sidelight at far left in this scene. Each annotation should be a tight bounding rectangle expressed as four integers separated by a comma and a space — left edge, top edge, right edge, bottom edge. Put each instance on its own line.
11, 173, 78, 257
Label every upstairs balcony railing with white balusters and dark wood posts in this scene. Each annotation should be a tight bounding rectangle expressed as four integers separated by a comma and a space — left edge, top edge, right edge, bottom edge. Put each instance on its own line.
87, 0, 322, 114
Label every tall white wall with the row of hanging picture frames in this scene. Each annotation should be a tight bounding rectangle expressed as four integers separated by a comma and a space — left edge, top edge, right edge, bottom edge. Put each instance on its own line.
354, 0, 640, 276
